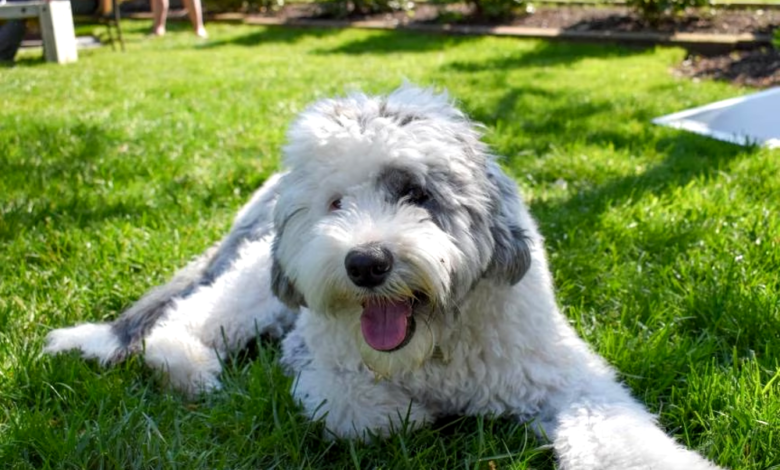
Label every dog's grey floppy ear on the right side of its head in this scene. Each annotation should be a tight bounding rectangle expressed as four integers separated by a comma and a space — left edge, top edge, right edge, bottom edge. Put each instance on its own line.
485, 161, 531, 284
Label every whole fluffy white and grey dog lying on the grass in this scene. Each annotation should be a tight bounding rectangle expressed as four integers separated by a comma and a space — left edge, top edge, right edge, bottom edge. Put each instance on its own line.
46, 86, 717, 470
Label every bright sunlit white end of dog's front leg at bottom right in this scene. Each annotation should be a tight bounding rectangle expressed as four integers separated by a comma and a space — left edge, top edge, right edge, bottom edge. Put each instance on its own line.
542, 369, 718, 470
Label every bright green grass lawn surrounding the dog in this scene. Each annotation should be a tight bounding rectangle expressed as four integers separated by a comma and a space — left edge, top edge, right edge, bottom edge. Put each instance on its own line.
0, 22, 780, 470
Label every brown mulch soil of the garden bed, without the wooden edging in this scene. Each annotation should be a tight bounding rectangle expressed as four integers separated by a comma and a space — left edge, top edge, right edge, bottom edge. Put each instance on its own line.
247, 4, 780, 88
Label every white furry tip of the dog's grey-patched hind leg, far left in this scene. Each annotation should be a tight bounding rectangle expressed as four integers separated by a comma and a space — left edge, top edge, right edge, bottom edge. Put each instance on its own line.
43, 323, 122, 364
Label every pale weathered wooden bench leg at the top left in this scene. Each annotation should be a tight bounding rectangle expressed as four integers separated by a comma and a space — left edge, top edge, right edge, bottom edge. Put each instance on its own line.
39, 0, 78, 64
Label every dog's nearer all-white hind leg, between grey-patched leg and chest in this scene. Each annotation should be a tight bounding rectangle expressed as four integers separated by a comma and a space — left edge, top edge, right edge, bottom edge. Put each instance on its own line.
137, 238, 295, 394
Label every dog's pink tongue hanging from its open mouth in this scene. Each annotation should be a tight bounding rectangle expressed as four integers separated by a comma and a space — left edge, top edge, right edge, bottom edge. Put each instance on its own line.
360, 300, 412, 351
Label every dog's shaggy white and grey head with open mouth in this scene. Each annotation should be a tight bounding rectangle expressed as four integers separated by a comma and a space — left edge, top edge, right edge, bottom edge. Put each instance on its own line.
273, 87, 530, 376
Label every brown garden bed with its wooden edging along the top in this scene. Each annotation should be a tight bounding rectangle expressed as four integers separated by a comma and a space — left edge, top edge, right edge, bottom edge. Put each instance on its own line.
126, 0, 780, 88
